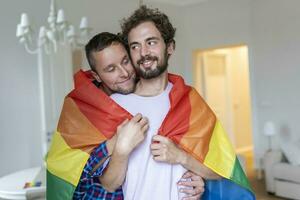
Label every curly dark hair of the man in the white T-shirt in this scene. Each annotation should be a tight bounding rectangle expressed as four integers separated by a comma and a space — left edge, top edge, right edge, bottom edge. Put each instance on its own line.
121, 5, 176, 47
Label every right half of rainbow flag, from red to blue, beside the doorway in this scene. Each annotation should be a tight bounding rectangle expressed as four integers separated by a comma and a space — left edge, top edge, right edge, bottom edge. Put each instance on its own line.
159, 75, 255, 199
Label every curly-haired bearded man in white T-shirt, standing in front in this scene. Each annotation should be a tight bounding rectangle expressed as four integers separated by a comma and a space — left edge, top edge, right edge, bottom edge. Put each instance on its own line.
96, 6, 220, 200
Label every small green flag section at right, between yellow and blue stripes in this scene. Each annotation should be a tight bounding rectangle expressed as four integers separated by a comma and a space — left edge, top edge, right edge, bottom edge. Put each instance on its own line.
230, 157, 252, 191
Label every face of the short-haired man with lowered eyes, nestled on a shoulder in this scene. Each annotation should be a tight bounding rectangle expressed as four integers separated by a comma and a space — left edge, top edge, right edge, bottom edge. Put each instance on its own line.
92, 43, 136, 94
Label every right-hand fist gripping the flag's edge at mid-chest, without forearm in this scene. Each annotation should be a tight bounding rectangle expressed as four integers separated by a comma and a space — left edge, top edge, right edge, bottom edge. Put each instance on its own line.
150, 135, 186, 164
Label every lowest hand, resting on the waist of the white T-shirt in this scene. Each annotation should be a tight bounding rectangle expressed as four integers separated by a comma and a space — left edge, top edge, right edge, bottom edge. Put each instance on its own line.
178, 171, 204, 200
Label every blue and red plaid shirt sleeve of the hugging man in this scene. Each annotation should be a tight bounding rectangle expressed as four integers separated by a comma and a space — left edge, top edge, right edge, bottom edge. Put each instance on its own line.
73, 142, 123, 200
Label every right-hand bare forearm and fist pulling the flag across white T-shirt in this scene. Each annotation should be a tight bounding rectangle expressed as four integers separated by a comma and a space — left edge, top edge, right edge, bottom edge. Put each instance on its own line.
150, 135, 221, 179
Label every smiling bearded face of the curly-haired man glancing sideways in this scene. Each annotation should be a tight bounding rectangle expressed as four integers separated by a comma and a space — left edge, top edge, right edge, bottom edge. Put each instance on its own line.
128, 21, 173, 79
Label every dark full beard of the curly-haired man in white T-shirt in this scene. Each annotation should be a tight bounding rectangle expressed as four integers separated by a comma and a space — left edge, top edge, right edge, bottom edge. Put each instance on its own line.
135, 49, 169, 79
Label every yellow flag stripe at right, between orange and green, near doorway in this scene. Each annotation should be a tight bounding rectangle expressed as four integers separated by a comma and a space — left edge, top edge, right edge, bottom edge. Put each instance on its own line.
204, 120, 236, 179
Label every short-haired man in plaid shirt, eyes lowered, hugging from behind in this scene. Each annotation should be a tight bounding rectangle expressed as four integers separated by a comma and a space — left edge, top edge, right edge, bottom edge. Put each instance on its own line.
73, 32, 209, 199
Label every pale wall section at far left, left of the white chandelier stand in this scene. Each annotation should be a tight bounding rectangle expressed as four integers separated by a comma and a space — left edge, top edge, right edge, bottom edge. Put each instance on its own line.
0, 0, 48, 175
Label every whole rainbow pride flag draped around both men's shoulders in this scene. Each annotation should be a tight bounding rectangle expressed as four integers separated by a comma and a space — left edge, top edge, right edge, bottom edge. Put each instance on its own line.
46, 71, 255, 200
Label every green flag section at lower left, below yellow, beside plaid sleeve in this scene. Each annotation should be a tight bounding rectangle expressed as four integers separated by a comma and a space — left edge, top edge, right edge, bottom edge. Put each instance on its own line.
47, 170, 75, 200
